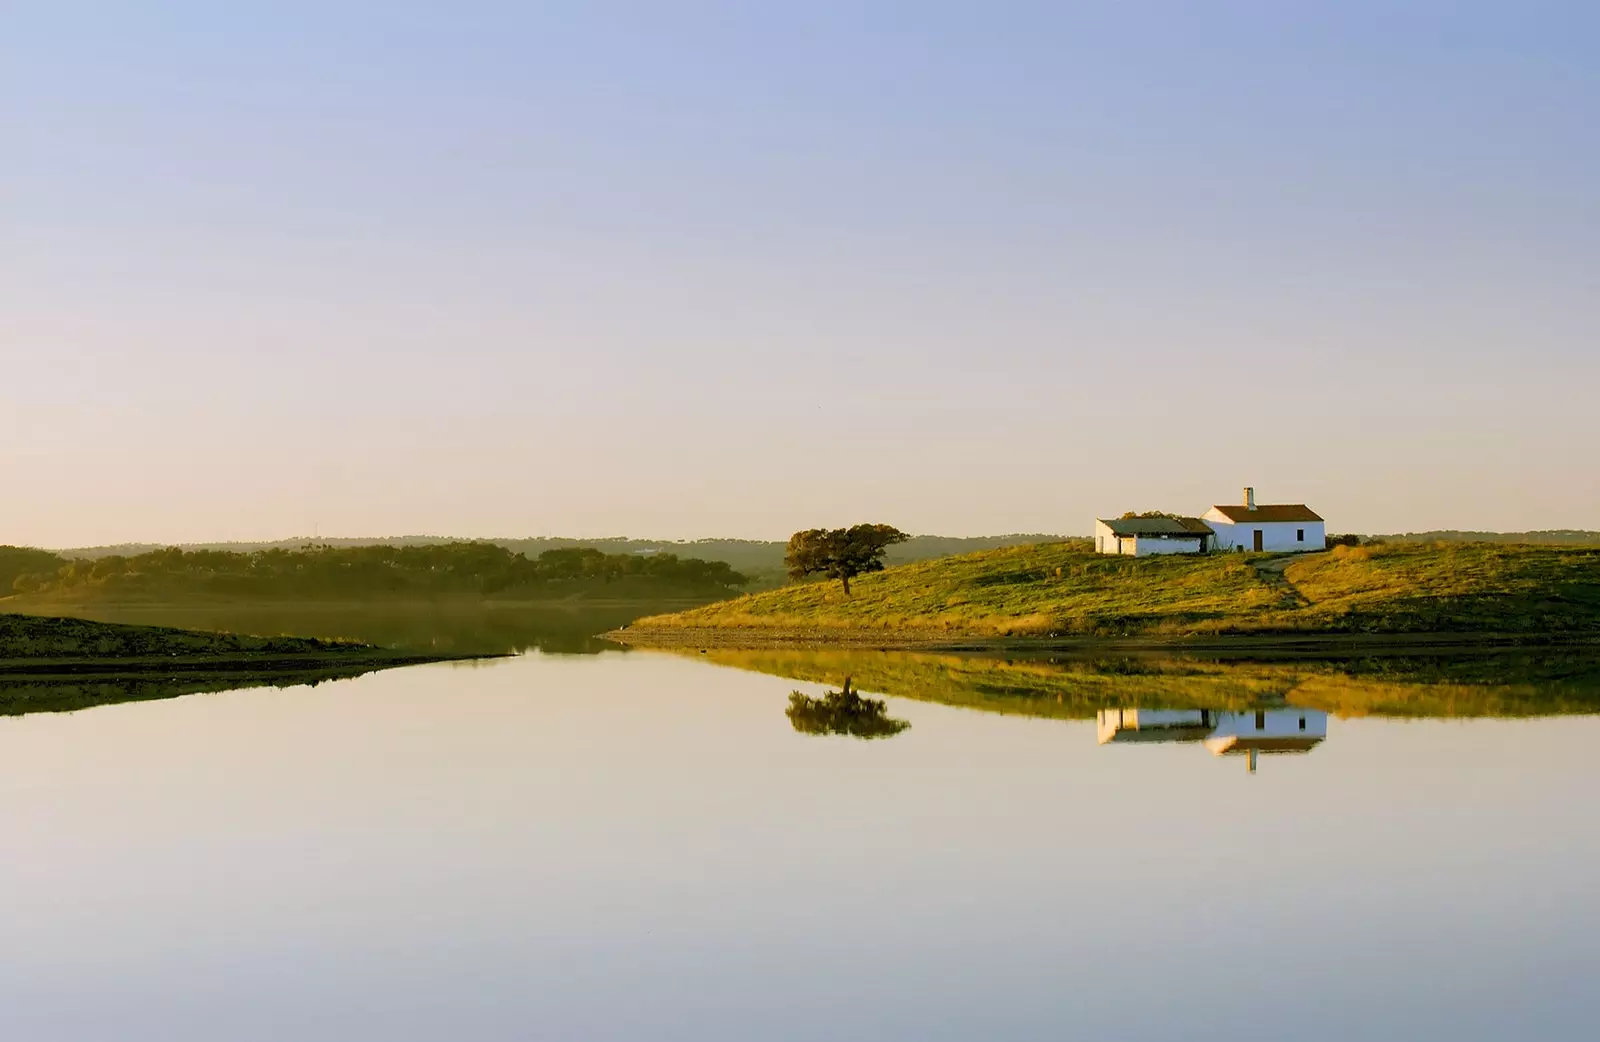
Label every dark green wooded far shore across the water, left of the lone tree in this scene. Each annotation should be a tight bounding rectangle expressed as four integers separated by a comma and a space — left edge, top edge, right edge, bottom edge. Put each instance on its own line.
0, 543, 747, 595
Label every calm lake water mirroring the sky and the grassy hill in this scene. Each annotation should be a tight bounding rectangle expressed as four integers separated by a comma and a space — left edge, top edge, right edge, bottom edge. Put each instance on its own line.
0, 614, 1600, 1042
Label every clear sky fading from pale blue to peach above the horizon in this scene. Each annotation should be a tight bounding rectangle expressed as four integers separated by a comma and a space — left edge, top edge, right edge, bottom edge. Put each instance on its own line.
0, 0, 1600, 547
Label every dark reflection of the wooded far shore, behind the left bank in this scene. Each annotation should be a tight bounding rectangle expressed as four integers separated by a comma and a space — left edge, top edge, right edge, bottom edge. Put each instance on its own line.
39, 602, 649, 655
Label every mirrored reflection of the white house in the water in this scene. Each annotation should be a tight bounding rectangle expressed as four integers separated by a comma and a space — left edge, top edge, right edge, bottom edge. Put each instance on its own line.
1098, 706, 1328, 773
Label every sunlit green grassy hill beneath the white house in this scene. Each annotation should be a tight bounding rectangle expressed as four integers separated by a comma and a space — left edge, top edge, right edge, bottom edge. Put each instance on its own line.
629, 543, 1600, 642
